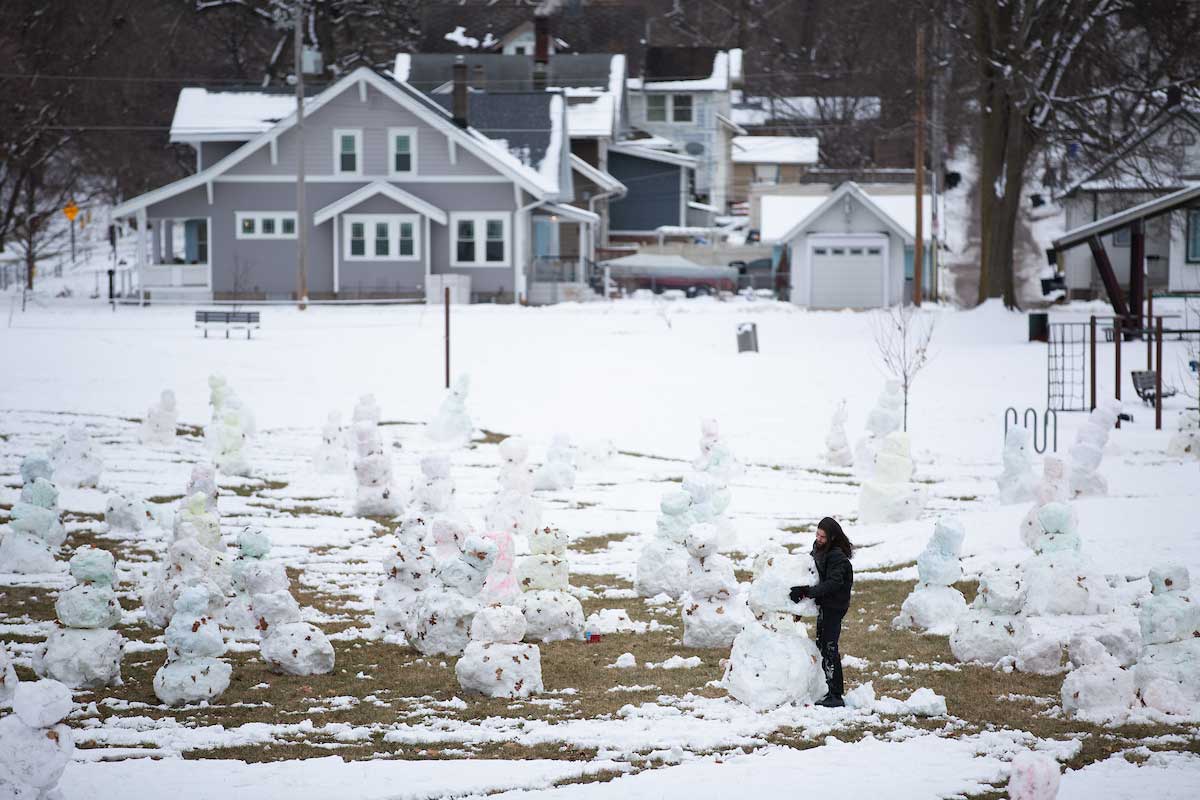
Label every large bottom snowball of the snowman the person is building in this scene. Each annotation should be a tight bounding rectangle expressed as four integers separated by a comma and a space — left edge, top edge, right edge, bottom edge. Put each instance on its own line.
721, 622, 826, 711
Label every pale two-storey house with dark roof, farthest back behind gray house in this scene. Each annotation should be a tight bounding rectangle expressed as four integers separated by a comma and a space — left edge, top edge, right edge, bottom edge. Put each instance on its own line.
629, 47, 745, 213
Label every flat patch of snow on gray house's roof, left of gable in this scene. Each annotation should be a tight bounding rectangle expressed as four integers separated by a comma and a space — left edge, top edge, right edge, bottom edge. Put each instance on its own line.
170, 86, 296, 142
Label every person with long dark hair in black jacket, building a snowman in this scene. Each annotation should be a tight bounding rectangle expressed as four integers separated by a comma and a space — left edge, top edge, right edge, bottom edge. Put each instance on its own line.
791, 517, 854, 708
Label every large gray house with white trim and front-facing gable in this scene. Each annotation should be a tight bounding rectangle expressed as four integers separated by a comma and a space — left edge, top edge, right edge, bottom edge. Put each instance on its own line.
114, 67, 598, 302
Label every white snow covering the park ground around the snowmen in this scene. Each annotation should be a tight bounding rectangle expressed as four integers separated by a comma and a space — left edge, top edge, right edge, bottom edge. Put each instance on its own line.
0, 300, 1200, 799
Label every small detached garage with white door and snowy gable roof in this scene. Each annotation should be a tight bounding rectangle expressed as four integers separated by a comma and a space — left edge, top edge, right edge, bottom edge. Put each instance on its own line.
762, 181, 932, 308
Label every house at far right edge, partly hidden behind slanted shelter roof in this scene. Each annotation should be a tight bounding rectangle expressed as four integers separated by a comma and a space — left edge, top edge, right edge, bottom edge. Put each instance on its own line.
1056, 106, 1200, 297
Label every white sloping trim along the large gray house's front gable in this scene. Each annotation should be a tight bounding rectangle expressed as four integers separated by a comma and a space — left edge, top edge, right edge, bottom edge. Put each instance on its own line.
113, 67, 556, 217
